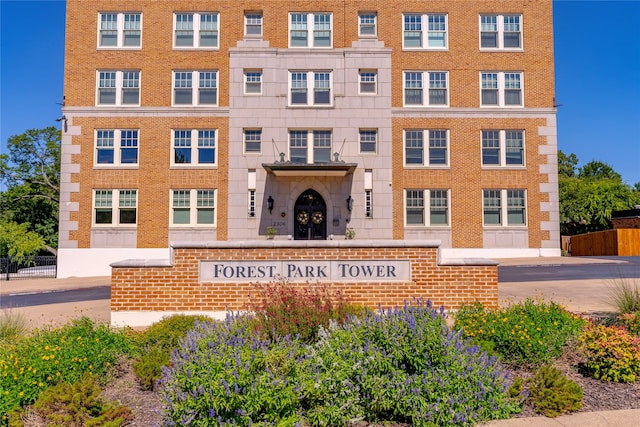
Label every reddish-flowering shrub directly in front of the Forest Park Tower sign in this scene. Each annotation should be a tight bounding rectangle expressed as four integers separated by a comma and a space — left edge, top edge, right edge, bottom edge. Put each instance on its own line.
248, 277, 358, 343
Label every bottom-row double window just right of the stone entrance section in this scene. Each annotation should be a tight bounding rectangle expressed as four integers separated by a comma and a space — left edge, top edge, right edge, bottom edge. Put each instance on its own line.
405, 189, 450, 227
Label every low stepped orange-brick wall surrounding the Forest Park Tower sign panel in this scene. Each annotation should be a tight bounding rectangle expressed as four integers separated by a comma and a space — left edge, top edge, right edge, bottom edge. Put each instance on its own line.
111, 241, 498, 316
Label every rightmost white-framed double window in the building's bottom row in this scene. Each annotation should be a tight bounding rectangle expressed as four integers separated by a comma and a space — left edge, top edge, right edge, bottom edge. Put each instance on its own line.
482, 189, 527, 227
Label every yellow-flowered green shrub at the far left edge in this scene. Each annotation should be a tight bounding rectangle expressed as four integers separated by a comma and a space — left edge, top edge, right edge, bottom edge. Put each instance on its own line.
0, 317, 131, 425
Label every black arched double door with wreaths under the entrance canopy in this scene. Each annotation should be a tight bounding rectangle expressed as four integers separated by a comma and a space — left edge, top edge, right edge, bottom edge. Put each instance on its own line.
293, 189, 327, 240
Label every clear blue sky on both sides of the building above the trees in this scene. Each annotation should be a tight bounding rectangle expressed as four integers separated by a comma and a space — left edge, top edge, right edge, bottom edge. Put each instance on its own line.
0, 0, 640, 184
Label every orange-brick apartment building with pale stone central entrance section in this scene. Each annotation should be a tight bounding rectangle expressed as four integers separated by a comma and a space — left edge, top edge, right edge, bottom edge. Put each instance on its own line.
58, 0, 560, 277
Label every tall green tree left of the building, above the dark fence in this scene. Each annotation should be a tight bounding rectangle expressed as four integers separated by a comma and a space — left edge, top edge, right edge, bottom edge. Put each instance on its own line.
0, 126, 61, 251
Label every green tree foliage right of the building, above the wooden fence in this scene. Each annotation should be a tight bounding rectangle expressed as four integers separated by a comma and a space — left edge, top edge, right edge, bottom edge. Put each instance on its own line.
558, 150, 640, 235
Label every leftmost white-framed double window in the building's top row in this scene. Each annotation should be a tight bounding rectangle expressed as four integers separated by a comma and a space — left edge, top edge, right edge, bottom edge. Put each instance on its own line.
98, 12, 142, 49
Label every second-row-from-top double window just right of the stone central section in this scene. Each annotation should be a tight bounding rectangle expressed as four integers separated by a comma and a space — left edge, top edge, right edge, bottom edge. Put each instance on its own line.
403, 71, 449, 107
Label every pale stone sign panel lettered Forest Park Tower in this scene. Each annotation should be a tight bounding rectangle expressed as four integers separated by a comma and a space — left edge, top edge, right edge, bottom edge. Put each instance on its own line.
200, 260, 411, 282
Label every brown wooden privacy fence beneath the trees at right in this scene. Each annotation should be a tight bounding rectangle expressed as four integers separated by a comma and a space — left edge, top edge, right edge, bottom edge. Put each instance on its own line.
571, 228, 640, 256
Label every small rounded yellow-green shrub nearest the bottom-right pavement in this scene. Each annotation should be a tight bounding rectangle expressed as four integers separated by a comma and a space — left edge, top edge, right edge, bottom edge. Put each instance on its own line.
527, 366, 583, 417
